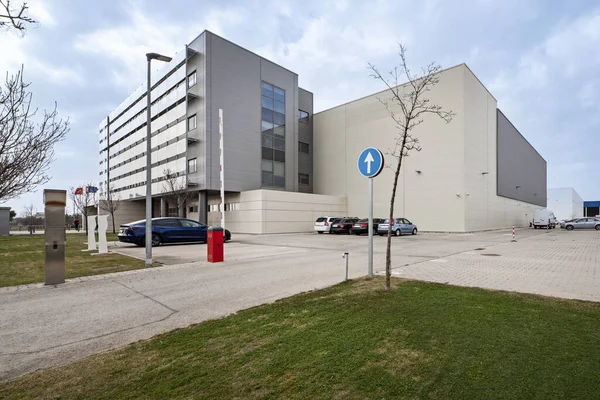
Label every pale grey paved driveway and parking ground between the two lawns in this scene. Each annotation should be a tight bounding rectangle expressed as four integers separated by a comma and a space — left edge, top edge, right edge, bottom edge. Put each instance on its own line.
0, 229, 600, 380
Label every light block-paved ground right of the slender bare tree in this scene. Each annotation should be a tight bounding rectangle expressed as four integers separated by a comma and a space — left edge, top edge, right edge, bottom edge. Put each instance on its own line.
392, 230, 600, 301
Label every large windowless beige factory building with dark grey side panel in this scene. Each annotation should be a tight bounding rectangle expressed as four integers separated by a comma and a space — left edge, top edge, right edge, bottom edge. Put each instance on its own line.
313, 64, 546, 232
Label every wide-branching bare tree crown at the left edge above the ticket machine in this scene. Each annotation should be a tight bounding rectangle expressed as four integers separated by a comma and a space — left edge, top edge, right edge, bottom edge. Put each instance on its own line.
0, 69, 69, 201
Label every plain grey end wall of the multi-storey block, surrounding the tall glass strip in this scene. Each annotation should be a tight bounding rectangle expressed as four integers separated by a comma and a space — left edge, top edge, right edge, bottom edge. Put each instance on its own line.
206, 32, 298, 192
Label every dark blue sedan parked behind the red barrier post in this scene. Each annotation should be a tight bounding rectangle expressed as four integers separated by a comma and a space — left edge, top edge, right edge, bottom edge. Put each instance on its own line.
118, 218, 231, 247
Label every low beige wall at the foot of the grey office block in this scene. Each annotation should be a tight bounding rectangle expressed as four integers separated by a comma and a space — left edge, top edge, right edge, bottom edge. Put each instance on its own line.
208, 190, 347, 234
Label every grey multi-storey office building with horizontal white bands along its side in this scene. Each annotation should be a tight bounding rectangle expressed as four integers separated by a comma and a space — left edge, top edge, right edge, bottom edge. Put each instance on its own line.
99, 31, 313, 222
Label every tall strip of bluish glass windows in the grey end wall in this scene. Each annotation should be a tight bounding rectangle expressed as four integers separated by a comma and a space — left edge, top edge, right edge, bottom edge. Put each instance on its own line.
261, 82, 285, 187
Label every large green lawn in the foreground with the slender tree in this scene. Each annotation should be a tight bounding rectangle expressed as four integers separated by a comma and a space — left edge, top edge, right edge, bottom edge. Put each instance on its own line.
0, 279, 600, 399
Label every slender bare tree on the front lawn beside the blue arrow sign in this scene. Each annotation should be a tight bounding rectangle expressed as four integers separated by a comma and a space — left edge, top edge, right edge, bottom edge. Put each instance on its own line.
369, 44, 454, 291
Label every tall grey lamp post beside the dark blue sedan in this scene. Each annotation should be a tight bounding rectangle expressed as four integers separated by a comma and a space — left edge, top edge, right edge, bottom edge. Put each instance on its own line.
145, 53, 171, 267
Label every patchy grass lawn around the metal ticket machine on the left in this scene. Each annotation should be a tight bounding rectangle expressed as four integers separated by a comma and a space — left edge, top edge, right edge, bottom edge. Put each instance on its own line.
0, 233, 159, 287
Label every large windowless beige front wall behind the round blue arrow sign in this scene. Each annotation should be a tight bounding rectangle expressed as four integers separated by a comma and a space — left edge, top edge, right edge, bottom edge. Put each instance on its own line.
314, 65, 466, 231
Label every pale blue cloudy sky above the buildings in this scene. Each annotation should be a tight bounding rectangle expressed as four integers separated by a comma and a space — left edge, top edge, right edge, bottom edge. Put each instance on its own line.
0, 0, 600, 213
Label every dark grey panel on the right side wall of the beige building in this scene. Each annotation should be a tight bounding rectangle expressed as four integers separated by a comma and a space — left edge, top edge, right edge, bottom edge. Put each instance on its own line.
497, 110, 546, 208
